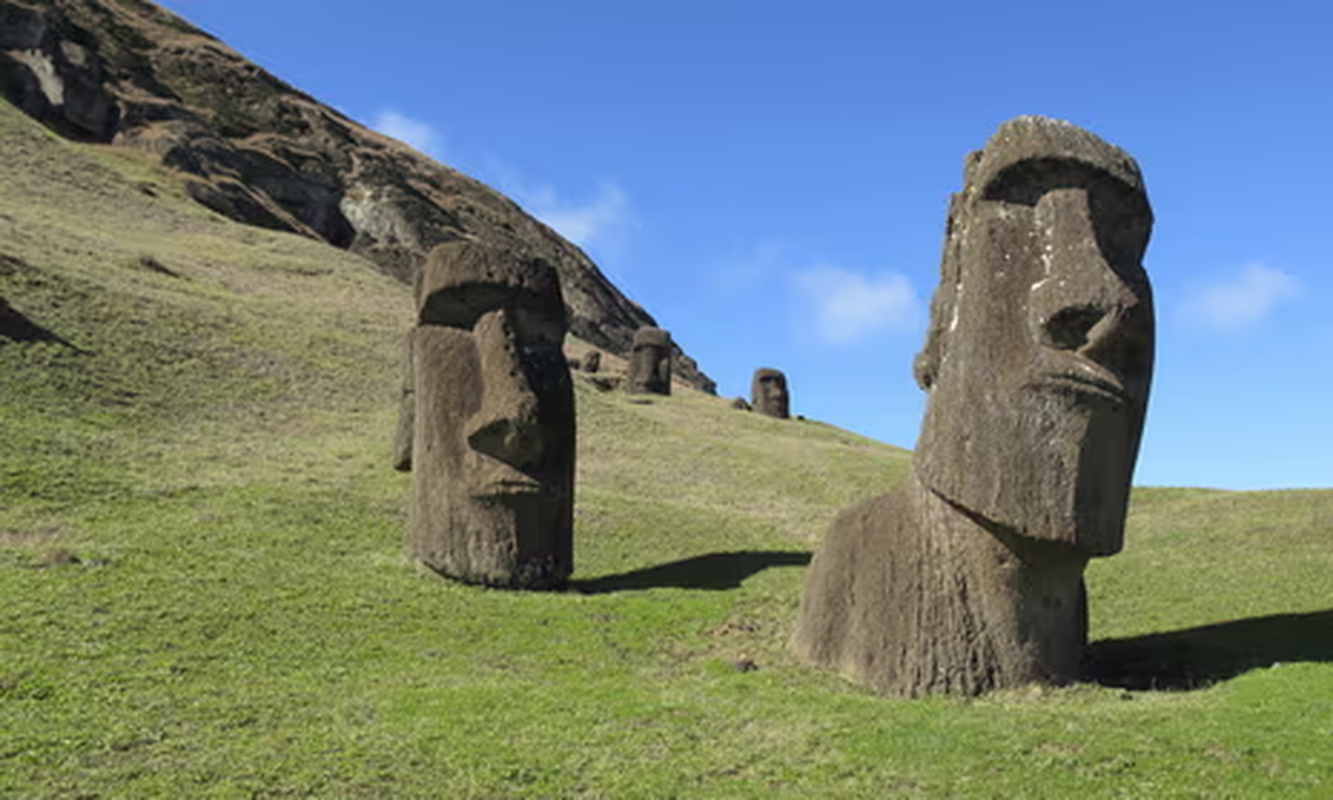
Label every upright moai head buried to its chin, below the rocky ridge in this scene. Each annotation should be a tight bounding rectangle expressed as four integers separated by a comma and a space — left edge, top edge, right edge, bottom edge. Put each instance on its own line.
408, 241, 575, 589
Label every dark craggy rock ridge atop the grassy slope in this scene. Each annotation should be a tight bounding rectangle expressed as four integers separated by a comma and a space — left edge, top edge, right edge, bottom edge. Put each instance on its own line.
0, 0, 714, 392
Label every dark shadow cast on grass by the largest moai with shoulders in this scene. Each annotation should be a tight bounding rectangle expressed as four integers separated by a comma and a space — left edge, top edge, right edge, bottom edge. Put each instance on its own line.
1085, 609, 1333, 691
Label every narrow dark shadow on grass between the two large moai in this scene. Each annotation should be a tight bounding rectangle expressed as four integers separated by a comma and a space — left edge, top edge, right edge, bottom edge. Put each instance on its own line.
569, 551, 810, 595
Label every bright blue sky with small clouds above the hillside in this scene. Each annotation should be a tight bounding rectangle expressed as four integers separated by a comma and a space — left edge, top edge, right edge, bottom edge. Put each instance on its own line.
165, 0, 1333, 488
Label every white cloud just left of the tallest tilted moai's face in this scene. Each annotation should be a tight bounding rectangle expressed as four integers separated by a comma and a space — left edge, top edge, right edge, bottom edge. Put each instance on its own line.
792, 264, 918, 344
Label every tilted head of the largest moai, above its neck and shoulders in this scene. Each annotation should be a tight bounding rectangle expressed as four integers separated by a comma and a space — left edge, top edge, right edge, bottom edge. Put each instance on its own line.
913, 117, 1153, 556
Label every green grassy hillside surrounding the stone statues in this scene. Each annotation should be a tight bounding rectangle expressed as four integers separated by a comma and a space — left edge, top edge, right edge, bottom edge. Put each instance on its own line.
0, 104, 1333, 797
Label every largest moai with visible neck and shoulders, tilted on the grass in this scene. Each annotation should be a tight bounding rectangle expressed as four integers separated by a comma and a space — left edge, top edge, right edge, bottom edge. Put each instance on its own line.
793, 117, 1153, 696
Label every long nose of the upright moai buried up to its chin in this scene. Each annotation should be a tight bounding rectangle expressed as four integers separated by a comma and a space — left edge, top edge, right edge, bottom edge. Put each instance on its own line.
467, 311, 543, 465
